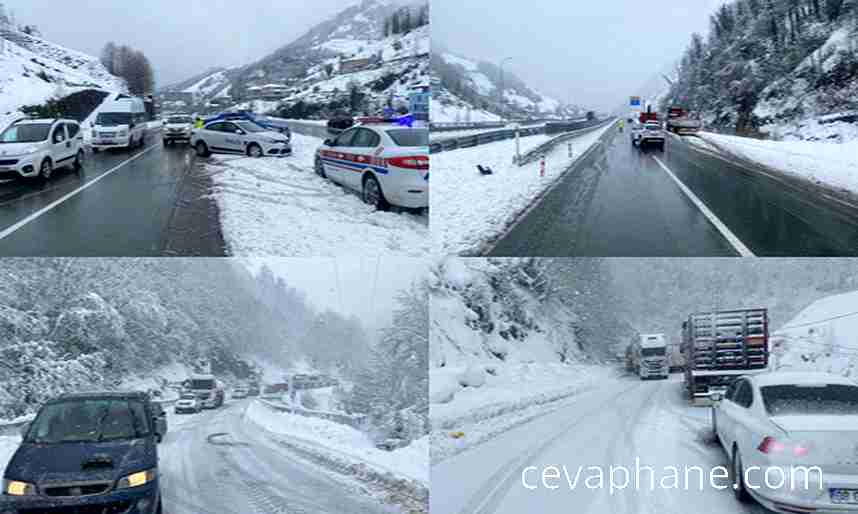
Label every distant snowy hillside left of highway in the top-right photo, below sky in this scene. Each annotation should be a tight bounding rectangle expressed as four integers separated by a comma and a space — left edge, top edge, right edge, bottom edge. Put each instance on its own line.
432, 51, 579, 121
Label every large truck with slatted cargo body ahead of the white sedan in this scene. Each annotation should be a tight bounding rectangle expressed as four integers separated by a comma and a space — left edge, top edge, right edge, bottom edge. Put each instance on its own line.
682, 308, 769, 405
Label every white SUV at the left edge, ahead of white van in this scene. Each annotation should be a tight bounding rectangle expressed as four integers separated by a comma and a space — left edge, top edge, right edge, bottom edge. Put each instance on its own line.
0, 119, 84, 180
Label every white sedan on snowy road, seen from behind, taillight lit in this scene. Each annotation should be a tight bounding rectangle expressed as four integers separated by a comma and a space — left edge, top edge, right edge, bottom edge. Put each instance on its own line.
712, 372, 858, 513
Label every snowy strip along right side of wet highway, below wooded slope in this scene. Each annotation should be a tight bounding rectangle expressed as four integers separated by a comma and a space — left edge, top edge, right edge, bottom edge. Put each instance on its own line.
699, 132, 858, 193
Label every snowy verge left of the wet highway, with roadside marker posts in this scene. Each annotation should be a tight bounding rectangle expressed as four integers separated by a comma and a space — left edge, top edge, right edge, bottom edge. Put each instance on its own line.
430, 125, 613, 255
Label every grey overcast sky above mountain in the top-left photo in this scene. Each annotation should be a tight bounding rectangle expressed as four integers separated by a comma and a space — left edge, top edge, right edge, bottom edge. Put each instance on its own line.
3, 0, 357, 87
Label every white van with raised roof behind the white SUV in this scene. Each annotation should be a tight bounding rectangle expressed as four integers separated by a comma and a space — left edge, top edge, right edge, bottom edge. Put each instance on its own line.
91, 95, 147, 152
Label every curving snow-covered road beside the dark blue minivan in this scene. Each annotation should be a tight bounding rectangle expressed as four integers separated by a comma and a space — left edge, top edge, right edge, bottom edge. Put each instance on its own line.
158, 400, 395, 514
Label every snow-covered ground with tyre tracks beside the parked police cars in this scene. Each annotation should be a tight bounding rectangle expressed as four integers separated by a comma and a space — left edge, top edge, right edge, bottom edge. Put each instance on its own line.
206, 130, 430, 257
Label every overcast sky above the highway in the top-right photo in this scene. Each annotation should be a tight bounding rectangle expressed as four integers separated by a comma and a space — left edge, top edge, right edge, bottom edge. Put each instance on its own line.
432, 0, 724, 110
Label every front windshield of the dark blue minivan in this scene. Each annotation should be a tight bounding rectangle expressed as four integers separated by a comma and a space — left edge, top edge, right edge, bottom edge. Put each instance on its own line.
26, 398, 149, 444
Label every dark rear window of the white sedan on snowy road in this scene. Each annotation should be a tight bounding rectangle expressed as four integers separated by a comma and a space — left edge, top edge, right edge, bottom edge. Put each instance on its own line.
760, 384, 858, 416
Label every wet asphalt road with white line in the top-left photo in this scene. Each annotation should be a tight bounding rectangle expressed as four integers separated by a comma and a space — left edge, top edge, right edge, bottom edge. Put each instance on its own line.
0, 130, 226, 257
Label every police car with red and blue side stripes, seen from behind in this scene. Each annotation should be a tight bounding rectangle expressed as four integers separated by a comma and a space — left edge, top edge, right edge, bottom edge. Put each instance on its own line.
315, 118, 429, 210
